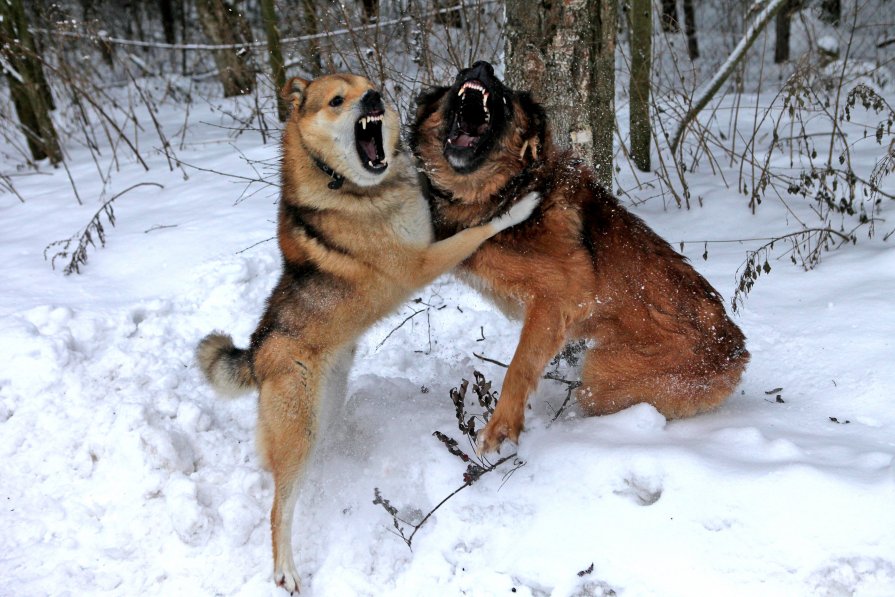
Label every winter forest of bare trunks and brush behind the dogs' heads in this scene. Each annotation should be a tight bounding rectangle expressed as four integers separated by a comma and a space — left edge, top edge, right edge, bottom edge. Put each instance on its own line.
0, 0, 895, 284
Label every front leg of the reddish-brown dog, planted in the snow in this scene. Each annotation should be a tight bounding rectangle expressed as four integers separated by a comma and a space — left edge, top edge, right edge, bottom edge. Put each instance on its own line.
476, 303, 566, 454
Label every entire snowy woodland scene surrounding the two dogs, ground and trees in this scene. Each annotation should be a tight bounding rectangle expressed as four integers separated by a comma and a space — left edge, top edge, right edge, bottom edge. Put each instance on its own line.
0, 0, 895, 596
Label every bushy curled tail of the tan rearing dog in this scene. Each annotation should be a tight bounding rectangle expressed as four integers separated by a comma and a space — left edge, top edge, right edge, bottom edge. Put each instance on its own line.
196, 332, 256, 397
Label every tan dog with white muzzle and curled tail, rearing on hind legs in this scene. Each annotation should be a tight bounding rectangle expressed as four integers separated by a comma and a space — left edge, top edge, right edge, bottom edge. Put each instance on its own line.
197, 75, 537, 592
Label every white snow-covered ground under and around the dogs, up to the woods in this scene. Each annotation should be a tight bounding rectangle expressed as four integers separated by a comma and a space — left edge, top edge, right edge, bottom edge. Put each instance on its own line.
0, 79, 895, 597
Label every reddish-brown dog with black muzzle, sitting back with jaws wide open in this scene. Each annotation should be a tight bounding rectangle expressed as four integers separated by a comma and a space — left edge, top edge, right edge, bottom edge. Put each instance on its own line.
411, 63, 749, 452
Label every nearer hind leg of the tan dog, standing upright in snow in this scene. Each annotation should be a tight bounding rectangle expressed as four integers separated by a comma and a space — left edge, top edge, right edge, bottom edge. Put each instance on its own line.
257, 344, 322, 593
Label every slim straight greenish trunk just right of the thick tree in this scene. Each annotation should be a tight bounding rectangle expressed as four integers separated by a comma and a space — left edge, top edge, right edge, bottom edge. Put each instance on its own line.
629, 0, 653, 172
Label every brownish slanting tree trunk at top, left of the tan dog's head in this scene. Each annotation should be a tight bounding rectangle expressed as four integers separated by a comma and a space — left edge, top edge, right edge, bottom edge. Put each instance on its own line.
196, 0, 255, 97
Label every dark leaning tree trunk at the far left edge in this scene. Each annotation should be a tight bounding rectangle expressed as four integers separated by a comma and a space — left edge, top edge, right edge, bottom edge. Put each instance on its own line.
0, 0, 62, 165
